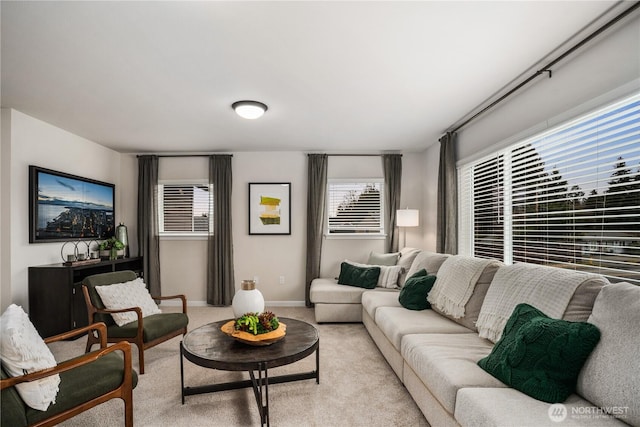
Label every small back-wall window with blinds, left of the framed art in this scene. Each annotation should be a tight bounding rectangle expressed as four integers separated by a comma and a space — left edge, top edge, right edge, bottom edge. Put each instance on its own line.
158, 183, 213, 236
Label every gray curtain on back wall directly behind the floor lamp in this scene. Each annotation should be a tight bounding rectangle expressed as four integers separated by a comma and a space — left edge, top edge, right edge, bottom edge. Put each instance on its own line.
382, 154, 402, 252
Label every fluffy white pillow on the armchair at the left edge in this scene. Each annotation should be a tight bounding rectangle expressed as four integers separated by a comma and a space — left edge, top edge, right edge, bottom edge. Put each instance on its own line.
0, 304, 60, 411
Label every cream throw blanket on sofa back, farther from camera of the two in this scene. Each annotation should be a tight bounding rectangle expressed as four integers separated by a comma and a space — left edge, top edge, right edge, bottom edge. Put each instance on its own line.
427, 255, 502, 319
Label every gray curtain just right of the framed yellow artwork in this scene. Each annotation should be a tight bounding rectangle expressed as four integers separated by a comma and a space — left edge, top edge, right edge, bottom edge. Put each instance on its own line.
305, 154, 328, 307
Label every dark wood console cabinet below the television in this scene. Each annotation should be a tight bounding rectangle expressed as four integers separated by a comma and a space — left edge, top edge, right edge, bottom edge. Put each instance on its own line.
29, 257, 142, 338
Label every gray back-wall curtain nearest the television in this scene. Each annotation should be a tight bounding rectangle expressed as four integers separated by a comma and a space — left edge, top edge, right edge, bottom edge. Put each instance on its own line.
138, 156, 162, 296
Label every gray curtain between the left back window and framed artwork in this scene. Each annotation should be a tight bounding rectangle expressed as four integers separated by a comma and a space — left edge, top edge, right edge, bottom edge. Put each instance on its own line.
207, 155, 235, 306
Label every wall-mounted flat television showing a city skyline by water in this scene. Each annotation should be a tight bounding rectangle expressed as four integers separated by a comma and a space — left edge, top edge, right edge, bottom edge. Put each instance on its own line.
29, 165, 115, 243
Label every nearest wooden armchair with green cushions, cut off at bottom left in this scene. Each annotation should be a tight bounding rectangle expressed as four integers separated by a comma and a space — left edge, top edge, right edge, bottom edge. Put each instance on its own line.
0, 323, 138, 427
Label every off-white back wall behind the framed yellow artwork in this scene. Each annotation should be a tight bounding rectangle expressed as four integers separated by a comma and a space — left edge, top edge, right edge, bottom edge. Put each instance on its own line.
159, 152, 422, 305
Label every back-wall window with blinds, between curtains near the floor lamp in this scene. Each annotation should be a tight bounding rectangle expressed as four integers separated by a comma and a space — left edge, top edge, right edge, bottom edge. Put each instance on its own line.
327, 179, 384, 237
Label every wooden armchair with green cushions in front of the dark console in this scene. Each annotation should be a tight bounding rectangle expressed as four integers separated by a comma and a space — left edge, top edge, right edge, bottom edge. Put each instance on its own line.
82, 270, 189, 374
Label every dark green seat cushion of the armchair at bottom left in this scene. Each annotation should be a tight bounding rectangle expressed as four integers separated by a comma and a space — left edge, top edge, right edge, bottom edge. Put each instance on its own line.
26, 352, 138, 426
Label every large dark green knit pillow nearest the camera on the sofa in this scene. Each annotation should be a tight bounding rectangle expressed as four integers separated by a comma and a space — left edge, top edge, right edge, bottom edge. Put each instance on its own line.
478, 304, 600, 403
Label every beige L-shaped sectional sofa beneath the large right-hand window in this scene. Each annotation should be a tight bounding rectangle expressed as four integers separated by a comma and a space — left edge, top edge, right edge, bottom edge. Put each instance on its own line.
310, 248, 640, 427
